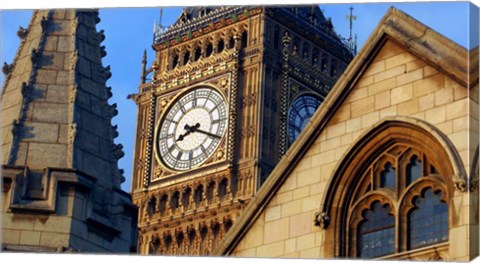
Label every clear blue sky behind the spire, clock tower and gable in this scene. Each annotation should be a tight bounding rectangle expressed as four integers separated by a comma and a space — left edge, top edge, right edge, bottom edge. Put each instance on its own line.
0, 2, 478, 191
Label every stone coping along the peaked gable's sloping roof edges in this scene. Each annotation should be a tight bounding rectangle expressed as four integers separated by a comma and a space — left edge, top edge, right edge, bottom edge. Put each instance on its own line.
212, 7, 468, 256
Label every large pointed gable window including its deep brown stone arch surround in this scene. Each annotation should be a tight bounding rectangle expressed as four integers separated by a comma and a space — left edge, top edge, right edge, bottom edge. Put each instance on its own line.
322, 120, 465, 259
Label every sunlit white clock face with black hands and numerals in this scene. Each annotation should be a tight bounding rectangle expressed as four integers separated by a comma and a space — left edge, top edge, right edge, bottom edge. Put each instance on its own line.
157, 88, 227, 171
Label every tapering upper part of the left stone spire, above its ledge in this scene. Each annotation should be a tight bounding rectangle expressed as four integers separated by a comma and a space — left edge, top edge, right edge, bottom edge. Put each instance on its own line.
0, 9, 123, 188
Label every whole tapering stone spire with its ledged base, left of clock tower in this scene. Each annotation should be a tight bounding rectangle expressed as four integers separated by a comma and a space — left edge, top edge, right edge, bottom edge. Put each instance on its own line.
1, 10, 137, 253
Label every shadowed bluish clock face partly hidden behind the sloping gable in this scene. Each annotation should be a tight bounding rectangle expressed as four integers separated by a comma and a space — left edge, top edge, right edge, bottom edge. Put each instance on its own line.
288, 95, 322, 144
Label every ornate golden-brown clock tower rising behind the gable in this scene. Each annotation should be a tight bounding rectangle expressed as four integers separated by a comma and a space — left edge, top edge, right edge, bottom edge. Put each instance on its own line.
132, 6, 352, 255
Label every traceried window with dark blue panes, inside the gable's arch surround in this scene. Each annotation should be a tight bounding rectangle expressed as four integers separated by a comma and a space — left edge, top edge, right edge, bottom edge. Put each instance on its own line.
348, 144, 448, 258
